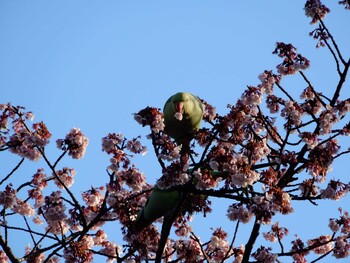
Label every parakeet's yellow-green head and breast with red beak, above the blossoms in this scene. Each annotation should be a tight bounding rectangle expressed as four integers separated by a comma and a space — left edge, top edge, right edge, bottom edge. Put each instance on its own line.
163, 92, 204, 151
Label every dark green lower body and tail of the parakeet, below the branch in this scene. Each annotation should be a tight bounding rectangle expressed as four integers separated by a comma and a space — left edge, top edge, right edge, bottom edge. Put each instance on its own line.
133, 185, 181, 232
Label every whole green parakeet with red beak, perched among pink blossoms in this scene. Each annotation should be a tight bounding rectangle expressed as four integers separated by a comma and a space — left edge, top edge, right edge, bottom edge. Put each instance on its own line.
131, 92, 204, 233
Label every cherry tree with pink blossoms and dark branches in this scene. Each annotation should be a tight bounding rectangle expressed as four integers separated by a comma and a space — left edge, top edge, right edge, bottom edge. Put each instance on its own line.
0, 0, 350, 263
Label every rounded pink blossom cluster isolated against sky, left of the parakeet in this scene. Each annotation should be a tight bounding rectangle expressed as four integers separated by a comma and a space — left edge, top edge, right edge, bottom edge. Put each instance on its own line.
56, 128, 89, 159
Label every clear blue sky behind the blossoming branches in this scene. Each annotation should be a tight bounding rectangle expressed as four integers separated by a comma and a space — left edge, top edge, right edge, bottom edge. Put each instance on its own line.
0, 0, 350, 262
